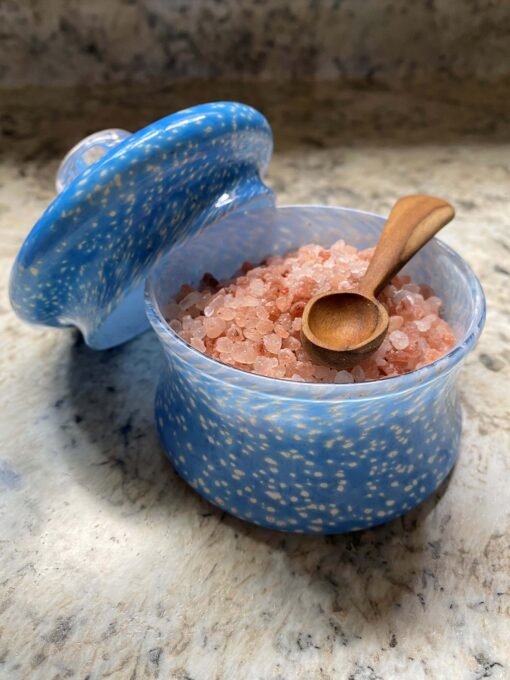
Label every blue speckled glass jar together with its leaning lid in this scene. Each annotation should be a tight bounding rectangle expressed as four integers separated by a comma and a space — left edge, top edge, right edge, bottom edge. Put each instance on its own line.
10, 102, 485, 533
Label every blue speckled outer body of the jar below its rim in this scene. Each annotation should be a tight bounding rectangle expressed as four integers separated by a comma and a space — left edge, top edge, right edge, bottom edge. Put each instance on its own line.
156, 357, 461, 533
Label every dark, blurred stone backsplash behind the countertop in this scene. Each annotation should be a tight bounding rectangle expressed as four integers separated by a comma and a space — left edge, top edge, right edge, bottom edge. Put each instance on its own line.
0, 0, 510, 86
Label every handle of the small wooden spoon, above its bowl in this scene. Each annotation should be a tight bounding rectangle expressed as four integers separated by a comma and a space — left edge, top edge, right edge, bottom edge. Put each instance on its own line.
358, 194, 455, 297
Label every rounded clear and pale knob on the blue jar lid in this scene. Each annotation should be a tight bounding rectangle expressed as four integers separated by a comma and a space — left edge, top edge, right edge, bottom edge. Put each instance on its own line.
55, 128, 131, 194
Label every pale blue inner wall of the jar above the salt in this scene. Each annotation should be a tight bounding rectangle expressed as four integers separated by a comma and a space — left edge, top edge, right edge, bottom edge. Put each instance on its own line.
151, 201, 479, 340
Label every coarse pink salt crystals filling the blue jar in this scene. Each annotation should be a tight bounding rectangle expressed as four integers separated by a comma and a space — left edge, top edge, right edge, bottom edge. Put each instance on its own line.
167, 241, 455, 384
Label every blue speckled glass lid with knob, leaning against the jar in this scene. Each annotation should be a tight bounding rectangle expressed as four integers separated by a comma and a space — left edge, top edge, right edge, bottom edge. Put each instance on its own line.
10, 102, 274, 349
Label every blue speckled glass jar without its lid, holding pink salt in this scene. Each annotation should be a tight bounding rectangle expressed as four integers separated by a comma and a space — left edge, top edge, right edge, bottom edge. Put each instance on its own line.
146, 206, 485, 533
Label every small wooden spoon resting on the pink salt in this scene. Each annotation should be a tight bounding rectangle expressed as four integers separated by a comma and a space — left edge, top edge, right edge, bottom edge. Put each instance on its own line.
301, 195, 455, 369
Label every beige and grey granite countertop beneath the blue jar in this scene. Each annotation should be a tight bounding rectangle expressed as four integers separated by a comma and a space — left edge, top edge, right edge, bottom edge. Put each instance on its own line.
0, 83, 510, 680
